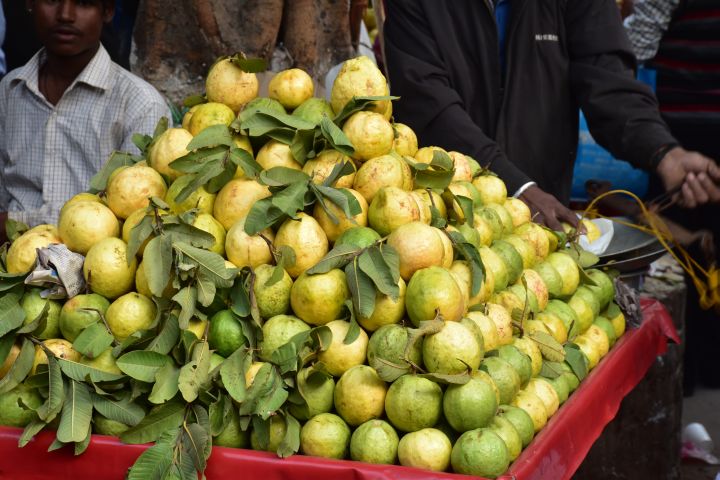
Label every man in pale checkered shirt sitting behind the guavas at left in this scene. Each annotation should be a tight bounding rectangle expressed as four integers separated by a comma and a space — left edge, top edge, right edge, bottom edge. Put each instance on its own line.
0, 0, 172, 241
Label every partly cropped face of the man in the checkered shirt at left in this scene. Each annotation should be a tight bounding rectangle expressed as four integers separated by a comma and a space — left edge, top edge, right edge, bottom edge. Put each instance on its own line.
28, 0, 114, 57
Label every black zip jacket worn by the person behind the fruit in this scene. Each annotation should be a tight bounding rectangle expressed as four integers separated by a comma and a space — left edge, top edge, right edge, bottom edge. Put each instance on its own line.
384, 0, 676, 201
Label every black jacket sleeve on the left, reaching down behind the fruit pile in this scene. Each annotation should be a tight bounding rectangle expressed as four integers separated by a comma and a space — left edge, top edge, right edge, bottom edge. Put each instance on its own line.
384, 0, 530, 192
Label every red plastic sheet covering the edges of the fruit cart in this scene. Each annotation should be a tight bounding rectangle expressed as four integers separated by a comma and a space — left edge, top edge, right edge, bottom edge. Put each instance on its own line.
0, 299, 679, 480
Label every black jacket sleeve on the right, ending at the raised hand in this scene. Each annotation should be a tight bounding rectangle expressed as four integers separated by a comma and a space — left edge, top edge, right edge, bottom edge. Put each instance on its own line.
565, 0, 678, 170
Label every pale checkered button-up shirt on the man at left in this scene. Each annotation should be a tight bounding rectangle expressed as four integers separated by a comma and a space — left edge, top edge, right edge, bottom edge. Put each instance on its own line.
0, 46, 172, 226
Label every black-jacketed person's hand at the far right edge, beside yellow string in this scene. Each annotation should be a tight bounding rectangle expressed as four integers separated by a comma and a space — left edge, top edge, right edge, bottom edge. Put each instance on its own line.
657, 147, 720, 208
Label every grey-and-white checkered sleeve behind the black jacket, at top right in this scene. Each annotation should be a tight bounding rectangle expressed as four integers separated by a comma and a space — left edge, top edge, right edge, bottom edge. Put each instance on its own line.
625, 0, 680, 63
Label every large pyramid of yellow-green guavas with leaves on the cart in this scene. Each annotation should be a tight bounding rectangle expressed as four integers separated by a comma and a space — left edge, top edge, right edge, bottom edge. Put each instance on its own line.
0, 57, 625, 479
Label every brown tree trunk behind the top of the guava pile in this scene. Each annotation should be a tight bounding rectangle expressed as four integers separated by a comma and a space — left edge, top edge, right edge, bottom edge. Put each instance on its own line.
131, 0, 354, 102
